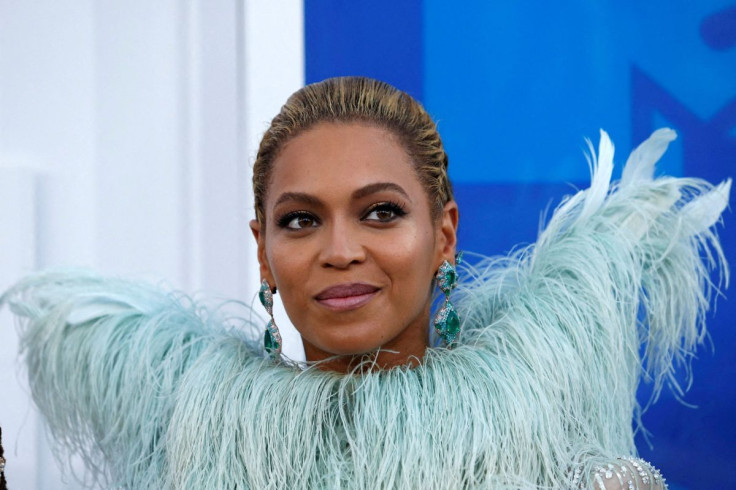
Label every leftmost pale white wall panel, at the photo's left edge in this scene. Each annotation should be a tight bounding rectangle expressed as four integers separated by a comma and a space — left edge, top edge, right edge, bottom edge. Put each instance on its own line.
0, 0, 95, 266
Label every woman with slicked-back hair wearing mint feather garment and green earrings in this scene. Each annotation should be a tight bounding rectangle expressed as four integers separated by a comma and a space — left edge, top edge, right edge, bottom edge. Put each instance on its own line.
8, 78, 729, 489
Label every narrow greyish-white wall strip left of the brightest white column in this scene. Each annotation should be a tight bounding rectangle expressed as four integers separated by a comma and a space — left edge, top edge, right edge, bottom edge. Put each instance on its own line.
184, 1, 247, 297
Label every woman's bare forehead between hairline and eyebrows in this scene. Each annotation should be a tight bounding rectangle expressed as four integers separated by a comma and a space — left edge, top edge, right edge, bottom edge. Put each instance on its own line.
268, 123, 424, 202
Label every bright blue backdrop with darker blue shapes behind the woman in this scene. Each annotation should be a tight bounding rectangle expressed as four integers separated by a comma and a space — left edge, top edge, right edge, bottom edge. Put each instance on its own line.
305, 0, 736, 489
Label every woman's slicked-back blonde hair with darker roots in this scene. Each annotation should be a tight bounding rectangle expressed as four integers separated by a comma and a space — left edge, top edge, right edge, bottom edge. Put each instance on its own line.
253, 77, 453, 225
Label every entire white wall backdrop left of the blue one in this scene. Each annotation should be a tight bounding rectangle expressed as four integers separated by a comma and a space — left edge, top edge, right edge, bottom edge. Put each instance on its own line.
0, 0, 303, 489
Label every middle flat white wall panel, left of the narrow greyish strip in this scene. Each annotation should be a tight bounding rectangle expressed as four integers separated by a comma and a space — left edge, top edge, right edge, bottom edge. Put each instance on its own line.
94, 0, 183, 285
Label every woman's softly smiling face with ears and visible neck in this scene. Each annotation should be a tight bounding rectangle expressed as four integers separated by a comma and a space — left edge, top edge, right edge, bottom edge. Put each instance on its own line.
251, 123, 457, 364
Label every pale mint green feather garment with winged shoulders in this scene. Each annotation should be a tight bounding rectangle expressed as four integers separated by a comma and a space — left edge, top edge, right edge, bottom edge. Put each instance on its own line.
5, 130, 730, 489
